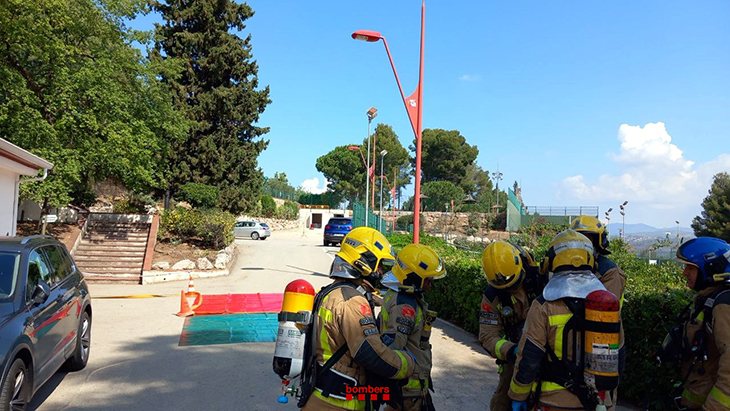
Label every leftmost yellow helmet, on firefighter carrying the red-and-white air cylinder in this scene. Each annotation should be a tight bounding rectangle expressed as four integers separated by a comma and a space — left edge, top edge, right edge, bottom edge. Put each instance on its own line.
330, 227, 395, 278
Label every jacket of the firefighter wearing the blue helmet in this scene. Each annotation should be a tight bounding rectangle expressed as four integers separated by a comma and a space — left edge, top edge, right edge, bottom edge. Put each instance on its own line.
682, 285, 730, 411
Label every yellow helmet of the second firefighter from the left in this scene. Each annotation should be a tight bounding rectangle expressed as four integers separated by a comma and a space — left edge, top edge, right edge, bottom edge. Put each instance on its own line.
393, 244, 446, 293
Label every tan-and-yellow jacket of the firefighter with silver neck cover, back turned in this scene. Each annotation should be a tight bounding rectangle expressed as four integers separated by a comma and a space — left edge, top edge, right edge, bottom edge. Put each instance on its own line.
509, 296, 613, 411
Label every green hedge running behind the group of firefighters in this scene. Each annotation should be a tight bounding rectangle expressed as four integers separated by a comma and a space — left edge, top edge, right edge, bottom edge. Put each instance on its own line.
391, 233, 692, 410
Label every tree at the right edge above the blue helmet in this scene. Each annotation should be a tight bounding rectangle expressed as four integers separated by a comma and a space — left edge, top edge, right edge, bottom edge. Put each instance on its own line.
692, 172, 730, 242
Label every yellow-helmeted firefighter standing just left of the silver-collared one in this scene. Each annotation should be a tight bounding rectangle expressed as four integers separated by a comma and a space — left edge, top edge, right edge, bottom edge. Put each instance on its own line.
479, 241, 545, 411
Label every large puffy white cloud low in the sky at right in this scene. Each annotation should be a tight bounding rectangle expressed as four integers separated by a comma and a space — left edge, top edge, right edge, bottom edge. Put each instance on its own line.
560, 122, 730, 225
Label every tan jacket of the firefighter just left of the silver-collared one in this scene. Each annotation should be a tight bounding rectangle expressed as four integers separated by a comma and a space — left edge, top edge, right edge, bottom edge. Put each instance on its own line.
479, 286, 530, 361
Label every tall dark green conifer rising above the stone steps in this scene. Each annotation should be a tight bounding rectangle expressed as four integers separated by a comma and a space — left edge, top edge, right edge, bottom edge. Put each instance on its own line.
151, 0, 271, 213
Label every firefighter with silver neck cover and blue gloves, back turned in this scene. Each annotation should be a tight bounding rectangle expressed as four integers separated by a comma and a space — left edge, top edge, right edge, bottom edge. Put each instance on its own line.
509, 229, 618, 411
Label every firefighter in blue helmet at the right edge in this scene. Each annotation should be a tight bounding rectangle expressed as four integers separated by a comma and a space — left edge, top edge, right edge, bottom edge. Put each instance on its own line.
657, 237, 730, 411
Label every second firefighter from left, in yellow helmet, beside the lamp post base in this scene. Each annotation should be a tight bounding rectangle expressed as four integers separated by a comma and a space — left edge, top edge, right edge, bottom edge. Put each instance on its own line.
380, 244, 446, 411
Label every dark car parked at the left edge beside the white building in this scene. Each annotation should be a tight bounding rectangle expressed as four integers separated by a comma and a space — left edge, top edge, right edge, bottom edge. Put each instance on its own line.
0, 236, 91, 411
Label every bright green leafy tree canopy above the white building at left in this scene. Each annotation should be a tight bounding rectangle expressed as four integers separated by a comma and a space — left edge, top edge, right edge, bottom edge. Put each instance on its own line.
0, 0, 187, 206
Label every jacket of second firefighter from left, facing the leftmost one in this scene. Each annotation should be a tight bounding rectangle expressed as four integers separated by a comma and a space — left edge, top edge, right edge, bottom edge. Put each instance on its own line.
380, 290, 435, 397
